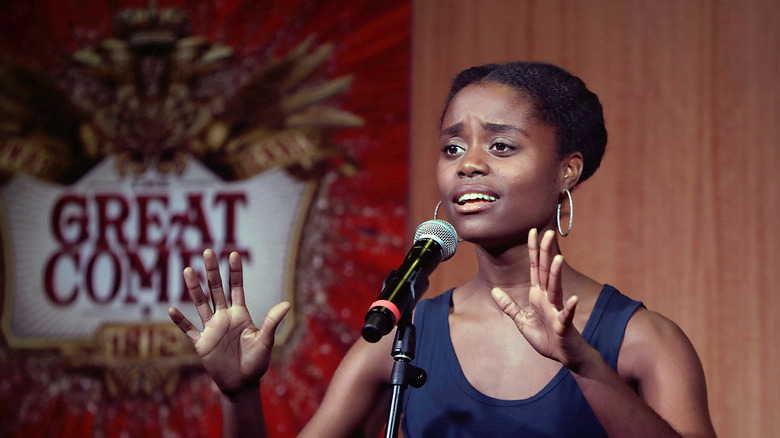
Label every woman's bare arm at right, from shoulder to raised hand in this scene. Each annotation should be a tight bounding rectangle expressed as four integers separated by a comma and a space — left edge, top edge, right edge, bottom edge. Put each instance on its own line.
493, 231, 715, 438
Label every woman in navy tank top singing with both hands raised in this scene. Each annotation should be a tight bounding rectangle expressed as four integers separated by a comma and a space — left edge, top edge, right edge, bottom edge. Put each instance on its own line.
169, 63, 714, 438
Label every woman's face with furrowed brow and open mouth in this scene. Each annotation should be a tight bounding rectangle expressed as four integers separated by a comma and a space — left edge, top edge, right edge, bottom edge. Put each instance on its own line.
436, 83, 571, 247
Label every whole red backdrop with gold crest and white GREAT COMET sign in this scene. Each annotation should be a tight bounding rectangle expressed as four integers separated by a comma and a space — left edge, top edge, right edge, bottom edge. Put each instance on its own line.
0, 0, 410, 437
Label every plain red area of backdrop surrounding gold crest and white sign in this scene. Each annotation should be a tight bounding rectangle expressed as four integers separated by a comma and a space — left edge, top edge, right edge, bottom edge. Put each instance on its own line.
0, 0, 410, 437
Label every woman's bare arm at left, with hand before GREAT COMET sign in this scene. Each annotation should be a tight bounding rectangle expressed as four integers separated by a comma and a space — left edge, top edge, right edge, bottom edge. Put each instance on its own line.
168, 250, 393, 437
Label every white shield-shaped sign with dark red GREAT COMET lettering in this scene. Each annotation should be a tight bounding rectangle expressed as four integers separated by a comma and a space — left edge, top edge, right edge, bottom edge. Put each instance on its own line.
0, 157, 314, 347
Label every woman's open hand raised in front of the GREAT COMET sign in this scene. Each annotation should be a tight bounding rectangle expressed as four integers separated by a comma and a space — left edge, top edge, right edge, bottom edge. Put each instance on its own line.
168, 249, 290, 396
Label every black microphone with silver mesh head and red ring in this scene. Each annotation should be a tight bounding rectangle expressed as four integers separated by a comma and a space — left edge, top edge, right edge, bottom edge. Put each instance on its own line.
361, 219, 458, 342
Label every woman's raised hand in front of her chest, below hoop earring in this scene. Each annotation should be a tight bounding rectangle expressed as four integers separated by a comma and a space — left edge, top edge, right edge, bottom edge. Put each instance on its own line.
491, 229, 587, 369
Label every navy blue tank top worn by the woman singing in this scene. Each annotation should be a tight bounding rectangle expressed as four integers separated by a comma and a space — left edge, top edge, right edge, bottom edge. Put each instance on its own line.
402, 285, 642, 438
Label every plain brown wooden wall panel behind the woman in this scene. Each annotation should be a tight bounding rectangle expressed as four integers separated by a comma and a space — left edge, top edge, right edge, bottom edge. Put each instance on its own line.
409, 0, 780, 437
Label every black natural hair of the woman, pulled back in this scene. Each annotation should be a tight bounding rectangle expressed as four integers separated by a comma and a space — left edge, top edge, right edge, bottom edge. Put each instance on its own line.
442, 62, 607, 182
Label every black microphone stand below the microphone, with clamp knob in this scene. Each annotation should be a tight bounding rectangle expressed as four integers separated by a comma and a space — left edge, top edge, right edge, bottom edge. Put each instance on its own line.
385, 312, 427, 438
